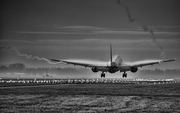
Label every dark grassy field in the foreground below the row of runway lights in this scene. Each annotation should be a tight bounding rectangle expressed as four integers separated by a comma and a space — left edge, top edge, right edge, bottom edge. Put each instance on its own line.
0, 83, 180, 113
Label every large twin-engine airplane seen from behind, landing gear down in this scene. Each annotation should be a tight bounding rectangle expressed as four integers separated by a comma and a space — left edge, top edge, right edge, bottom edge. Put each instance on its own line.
51, 44, 176, 78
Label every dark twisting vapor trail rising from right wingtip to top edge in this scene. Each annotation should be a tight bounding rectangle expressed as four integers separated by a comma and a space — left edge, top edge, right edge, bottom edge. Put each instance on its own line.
117, 0, 165, 59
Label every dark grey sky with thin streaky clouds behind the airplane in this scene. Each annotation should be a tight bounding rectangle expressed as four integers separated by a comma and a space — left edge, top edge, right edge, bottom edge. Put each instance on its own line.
0, 0, 180, 77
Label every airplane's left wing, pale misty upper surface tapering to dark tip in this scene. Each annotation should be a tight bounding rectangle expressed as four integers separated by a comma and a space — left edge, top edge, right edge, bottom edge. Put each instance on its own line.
51, 59, 107, 67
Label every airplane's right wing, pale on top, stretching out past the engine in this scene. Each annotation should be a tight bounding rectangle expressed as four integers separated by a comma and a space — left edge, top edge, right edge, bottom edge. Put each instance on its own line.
123, 58, 176, 67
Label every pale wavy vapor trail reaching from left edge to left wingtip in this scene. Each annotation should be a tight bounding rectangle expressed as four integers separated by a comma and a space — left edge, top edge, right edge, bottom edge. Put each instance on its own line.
0, 46, 58, 64
